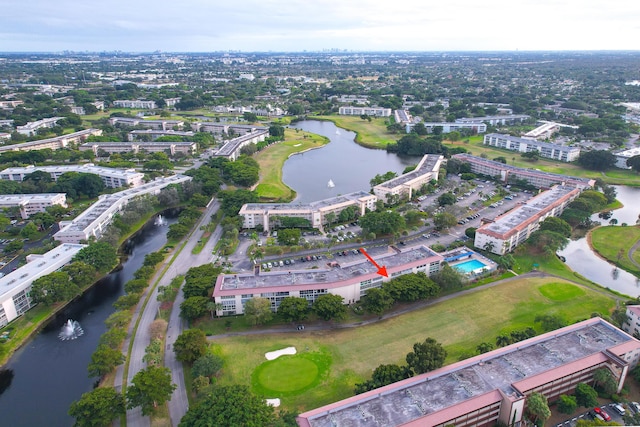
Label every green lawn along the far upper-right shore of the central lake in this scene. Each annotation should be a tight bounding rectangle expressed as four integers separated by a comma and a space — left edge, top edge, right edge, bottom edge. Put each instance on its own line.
309, 116, 404, 149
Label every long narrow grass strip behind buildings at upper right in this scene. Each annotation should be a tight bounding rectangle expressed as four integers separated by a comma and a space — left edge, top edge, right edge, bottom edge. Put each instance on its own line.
444, 135, 640, 186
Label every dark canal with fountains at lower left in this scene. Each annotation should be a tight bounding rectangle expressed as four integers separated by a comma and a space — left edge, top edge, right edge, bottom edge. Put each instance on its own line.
0, 213, 177, 427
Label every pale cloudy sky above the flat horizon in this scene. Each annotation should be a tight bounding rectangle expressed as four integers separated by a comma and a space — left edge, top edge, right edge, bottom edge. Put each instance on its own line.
0, 0, 640, 52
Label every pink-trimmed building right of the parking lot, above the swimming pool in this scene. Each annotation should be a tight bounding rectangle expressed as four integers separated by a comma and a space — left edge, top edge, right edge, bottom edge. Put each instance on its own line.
473, 185, 580, 255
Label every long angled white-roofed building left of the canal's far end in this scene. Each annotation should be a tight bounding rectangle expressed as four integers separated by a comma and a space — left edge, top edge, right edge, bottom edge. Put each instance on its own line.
53, 175, 191, 243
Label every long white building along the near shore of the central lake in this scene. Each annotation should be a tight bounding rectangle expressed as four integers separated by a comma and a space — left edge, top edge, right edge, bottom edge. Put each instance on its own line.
238, 191, 378, 231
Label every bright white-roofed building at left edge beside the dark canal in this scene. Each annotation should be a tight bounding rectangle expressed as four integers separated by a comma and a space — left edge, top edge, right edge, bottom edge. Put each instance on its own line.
0, 244, 86, 328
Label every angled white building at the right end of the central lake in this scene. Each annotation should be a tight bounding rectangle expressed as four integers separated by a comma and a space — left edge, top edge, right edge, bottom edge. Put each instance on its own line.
373, 154, 444, 201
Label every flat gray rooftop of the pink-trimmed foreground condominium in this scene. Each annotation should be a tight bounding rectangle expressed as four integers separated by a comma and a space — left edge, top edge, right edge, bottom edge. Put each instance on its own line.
303, 319, 631, 427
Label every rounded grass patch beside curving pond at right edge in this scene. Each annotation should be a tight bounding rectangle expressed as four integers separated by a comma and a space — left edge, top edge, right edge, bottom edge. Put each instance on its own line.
591, 226, 640, 277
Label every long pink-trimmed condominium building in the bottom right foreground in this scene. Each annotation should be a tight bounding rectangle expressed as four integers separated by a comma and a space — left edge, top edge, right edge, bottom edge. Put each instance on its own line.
297, 317, 640, 427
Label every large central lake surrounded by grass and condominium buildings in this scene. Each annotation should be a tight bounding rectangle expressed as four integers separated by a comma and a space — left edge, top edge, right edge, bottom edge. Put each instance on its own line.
282, 120, 420, 203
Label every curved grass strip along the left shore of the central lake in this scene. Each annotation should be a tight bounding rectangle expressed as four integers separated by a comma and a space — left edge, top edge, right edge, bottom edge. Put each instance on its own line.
255, 129, 329, 202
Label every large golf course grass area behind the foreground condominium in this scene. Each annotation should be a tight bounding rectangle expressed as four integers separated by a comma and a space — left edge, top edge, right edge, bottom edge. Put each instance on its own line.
212, 278, 615, 412
